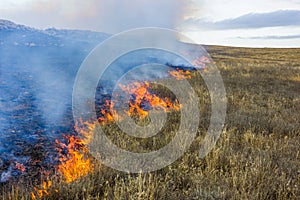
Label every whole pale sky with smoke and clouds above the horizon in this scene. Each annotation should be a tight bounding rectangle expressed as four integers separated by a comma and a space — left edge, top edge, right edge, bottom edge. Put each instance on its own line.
0, 0, 300, 47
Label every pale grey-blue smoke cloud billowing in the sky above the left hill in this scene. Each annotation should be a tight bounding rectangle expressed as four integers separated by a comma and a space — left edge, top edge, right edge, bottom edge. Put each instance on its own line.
0, 0, 190, 33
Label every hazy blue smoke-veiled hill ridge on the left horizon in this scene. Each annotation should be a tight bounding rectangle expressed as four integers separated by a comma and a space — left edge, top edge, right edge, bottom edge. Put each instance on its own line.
0, 19, 110, 47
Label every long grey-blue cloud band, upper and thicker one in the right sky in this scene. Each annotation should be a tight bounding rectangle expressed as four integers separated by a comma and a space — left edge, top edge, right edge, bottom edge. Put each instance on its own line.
185, 10, 300, 30
